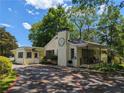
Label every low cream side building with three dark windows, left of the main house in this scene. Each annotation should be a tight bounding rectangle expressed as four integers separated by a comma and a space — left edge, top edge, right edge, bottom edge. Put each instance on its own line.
12, 47, 41, 64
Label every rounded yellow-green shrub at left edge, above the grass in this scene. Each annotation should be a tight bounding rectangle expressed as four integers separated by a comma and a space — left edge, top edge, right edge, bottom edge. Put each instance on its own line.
0, 56, 12, 78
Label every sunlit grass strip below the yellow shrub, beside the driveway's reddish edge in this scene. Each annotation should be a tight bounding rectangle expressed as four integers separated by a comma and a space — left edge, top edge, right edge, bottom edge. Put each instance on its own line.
0, 71, 16, 93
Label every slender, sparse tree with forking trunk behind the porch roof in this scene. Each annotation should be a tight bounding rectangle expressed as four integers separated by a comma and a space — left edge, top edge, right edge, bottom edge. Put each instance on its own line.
70, 7, 97, 41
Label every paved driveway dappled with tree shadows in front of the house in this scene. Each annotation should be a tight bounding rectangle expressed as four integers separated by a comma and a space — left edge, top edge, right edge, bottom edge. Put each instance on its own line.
9, 65, 124, 93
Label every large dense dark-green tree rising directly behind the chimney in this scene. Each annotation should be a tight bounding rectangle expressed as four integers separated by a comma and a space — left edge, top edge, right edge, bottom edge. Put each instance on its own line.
29, 6, 74, 47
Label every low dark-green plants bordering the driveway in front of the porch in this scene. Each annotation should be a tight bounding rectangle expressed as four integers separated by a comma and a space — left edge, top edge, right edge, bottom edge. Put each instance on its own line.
94, 63, 124, 72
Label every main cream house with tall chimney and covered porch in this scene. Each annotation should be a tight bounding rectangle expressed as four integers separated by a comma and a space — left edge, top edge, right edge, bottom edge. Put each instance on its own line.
44, 31, 107, 67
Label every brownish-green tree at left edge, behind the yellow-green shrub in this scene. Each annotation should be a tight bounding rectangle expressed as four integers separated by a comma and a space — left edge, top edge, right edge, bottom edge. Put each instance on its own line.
0, 27, 18, 56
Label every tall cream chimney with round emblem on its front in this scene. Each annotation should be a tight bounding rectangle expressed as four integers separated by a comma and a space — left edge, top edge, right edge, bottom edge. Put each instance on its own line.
58, 31, 69, 66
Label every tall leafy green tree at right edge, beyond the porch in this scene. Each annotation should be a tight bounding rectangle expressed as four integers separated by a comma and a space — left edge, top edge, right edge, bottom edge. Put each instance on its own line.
98, 3, 124, 56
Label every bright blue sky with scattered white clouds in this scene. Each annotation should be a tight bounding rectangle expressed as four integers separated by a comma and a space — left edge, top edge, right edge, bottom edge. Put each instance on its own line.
0, 0, 124, 46
